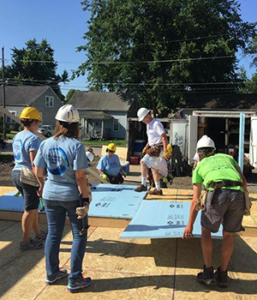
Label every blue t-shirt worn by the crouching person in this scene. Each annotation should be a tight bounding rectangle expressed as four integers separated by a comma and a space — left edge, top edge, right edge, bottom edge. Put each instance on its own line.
96, 154, 120, 176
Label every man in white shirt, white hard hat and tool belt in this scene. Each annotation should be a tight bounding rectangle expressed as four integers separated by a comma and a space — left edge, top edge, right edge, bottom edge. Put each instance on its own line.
135, 107, 169, 195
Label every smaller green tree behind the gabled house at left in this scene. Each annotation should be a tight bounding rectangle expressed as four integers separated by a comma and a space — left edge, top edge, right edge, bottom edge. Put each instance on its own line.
5, 39, 69, 100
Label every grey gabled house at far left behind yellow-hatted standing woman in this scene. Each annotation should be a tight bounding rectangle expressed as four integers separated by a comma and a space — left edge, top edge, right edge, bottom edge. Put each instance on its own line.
0, 85, 63, 125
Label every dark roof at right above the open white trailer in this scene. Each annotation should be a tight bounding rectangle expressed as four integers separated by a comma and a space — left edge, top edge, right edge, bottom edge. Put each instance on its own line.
180, 94, 257, 110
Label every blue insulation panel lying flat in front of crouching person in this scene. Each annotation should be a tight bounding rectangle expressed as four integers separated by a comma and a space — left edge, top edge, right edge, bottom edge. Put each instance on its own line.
88, 184, 146, 219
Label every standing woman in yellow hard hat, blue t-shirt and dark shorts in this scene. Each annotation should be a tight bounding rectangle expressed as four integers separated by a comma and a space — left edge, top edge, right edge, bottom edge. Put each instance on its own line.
12, 107, 46, 250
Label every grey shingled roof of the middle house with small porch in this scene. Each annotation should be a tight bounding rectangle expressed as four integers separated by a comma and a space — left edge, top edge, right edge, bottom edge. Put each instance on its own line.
69, 91, 133, 111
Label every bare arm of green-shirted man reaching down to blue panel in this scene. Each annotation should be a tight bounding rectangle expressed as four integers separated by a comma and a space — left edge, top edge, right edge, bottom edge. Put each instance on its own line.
182, 183, 202, 239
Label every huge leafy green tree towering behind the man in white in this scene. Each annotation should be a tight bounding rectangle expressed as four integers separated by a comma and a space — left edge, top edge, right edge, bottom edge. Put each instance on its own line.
73, 0, 255, 109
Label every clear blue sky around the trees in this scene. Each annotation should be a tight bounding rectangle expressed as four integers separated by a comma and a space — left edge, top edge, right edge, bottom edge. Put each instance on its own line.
0, 0, 257, 95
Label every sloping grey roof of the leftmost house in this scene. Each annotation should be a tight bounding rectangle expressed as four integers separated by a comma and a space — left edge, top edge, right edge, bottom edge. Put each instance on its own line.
0, 85, 50, 106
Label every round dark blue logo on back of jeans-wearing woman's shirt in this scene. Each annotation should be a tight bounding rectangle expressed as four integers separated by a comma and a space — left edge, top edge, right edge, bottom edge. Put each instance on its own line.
46, 147, 69, 175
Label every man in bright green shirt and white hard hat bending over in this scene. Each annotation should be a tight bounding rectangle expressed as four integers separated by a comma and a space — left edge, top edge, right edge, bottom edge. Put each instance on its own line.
183, 135, 247, 287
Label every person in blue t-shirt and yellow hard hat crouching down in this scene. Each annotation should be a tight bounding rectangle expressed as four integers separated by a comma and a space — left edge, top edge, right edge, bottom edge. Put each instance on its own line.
96, 143, 127, 184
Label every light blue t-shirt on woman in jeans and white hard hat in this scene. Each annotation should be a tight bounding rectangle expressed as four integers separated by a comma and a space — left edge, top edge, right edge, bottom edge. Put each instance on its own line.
34, 136, 88, 201
